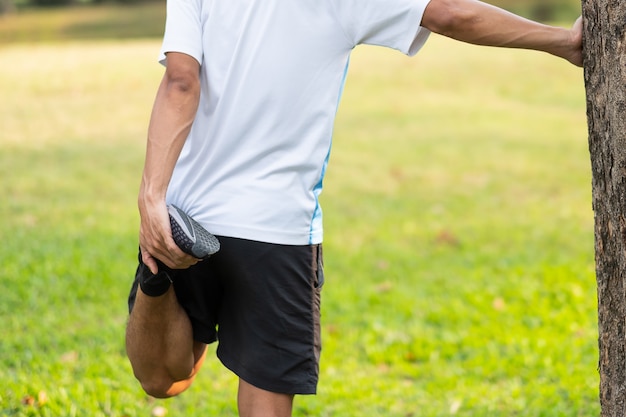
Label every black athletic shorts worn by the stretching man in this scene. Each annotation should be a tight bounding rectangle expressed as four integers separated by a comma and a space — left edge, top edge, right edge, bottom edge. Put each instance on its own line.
128, 237, 324, 394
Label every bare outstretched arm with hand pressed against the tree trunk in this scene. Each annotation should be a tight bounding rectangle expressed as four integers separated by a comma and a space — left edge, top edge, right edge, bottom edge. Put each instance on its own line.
422, 0, 582, 66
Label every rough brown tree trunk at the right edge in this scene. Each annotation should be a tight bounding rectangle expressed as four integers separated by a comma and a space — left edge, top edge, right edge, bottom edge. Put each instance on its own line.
582, 0, 626, 417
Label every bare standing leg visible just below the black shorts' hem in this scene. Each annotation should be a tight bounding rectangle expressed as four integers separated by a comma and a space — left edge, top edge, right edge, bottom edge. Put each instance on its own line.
237, 378, 293, 417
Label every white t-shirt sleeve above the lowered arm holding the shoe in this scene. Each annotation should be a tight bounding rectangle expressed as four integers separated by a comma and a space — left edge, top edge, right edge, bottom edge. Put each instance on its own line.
159, 0, 202, 65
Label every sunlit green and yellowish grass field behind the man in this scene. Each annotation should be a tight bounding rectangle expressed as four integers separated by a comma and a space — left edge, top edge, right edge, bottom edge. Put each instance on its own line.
0, 6, 599, 417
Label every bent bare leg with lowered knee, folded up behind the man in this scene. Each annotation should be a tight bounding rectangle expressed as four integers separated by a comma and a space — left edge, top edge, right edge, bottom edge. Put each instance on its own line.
126, 287, 206, 398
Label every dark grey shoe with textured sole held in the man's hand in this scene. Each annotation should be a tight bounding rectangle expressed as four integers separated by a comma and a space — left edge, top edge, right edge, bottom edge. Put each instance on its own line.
167, 205, 220, 259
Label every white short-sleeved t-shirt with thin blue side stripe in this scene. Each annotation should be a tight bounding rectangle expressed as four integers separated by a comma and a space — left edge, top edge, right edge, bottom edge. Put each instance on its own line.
160, 0, 429, 245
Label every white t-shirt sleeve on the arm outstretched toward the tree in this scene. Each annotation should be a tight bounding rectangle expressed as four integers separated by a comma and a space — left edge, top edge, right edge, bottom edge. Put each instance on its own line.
335, 0, 430, 55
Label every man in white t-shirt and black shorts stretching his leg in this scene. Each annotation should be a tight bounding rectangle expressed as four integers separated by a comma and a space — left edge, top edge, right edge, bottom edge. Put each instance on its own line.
127, 0, 582, 417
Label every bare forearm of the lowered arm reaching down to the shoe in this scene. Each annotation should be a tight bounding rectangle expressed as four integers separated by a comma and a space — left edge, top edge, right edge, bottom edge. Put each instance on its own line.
139, 74, 199, 203
